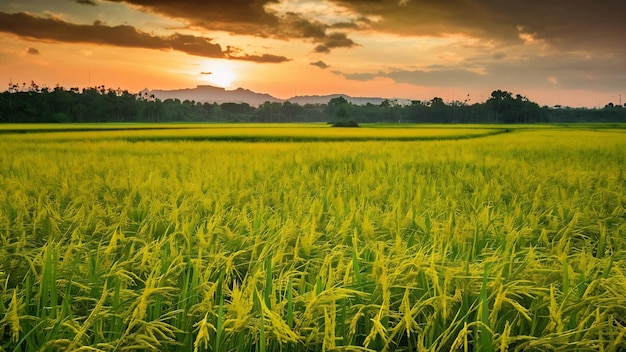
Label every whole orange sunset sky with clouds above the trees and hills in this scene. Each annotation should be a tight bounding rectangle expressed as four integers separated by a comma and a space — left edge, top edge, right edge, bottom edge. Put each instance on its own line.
0, 0, 626, 107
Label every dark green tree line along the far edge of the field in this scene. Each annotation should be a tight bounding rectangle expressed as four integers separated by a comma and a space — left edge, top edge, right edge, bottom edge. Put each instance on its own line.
0, 82, 626, 123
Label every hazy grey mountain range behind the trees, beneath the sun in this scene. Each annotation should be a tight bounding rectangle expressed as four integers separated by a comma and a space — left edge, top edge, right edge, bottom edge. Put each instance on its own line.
141, 85, 402, 106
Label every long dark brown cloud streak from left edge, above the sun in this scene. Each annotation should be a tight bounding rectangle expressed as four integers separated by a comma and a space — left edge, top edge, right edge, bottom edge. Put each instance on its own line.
0, 12, 288, 62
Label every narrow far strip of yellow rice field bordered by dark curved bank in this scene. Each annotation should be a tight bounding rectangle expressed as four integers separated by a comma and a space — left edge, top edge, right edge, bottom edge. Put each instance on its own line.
0, 124, 502, 142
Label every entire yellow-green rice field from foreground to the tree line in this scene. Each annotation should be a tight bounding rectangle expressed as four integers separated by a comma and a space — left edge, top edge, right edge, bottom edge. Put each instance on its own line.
0, 125, 626, 352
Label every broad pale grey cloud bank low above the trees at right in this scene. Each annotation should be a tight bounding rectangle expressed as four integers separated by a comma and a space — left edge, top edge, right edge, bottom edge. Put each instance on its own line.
333, 48, 626, 92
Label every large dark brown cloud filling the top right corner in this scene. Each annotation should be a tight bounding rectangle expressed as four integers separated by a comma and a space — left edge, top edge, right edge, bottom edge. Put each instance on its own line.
329, 0, 626, 51
